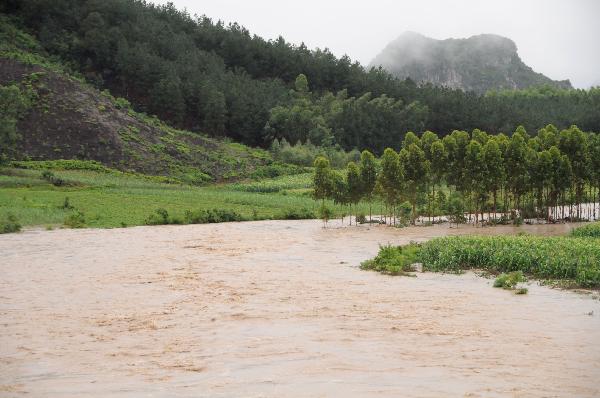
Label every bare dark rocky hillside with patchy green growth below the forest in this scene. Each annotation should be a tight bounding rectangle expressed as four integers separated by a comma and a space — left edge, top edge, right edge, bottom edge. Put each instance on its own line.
0, 20, 287, 184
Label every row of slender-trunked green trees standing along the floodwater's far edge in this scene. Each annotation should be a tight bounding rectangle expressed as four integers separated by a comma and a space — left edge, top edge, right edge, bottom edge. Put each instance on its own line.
314, 125, 600, 224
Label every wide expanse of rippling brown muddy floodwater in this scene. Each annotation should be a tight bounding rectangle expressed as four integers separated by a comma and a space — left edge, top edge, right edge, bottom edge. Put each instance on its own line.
0, 221, 600, 397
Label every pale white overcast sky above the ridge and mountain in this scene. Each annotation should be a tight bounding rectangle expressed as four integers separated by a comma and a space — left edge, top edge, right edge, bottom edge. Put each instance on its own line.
155, 0, 600, 88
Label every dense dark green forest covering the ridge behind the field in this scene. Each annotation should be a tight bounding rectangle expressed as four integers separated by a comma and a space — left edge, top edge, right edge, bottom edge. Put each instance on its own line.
0, 0, 600, 152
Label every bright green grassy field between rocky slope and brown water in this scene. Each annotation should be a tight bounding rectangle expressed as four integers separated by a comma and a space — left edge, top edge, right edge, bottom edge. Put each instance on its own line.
0, 162, 376, 228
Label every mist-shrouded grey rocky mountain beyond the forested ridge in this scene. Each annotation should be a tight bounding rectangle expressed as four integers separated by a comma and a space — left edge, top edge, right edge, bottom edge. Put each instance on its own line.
370, 32, 572, 93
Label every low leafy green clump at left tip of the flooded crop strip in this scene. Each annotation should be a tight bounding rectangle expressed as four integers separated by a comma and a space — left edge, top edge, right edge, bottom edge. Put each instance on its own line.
360, 243, 420, 275
